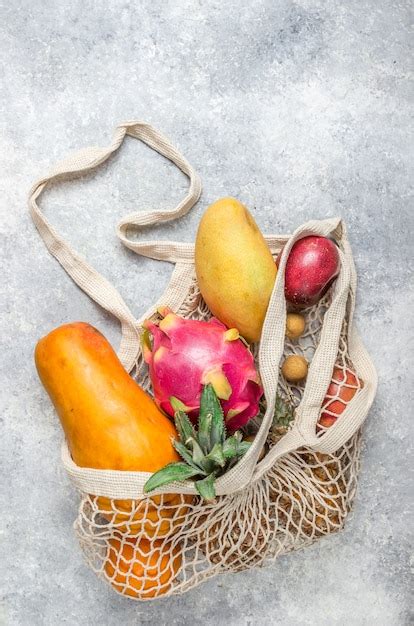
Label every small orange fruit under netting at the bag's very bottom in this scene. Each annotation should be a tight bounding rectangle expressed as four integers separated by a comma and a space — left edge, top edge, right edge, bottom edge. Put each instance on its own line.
104, 538, 182, 599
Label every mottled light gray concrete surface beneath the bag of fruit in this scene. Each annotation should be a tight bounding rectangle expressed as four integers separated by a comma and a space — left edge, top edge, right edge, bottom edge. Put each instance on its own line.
0, 0, 414, 626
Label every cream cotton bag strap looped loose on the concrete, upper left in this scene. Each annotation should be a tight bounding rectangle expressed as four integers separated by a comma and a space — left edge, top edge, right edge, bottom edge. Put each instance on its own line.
29, 121, 201, 371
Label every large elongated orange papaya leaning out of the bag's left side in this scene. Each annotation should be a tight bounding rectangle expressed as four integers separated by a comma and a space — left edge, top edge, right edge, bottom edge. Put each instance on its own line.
35, 322, 188, 537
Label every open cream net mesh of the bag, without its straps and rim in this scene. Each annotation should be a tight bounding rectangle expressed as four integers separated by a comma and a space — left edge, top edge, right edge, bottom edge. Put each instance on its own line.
75, 266, 362, 600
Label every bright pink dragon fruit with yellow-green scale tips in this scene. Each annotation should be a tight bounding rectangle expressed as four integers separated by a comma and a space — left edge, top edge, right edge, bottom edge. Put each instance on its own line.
143, 308, 263, 431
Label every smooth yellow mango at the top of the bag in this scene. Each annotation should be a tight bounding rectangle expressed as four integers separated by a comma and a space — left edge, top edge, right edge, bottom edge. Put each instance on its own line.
195, 198, 277, 342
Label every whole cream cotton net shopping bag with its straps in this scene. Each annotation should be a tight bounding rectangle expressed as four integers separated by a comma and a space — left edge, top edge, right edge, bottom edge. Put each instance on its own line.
29, 121, 377, 600
